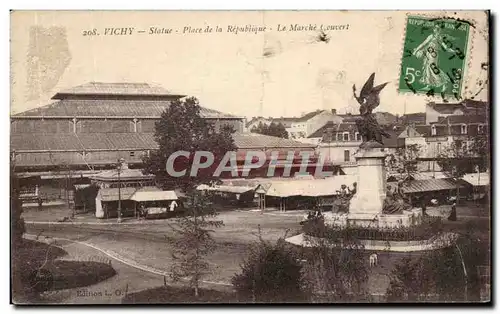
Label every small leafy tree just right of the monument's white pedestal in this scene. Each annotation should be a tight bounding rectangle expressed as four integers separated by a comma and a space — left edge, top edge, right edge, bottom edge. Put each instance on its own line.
386, 144, 421, 179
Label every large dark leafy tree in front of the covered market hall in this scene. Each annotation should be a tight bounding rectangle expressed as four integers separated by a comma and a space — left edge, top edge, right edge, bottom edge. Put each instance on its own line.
143, 97, 236, 190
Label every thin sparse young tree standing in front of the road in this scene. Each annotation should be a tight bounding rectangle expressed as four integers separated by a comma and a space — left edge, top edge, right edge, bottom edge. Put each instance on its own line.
168, 191, 223, 297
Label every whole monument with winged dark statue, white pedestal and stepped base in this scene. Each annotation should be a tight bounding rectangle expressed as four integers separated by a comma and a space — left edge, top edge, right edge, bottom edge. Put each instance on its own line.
324, 73, 422, 229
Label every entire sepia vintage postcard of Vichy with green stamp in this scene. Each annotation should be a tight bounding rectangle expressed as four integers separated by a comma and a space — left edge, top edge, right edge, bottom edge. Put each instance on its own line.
10, 10, 491, 305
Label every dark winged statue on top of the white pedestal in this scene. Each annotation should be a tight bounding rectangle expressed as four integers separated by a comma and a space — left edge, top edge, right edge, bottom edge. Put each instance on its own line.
352, 73, 390, 147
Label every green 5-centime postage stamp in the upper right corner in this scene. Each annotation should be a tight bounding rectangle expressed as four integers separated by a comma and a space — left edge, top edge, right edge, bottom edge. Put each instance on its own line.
399, 16, 471, 100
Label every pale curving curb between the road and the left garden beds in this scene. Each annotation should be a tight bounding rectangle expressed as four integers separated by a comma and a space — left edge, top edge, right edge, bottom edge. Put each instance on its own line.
23, 234, 233, 287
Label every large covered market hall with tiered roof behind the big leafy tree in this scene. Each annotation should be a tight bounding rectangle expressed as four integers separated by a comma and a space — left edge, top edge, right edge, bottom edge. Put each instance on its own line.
11, 83, 244, 172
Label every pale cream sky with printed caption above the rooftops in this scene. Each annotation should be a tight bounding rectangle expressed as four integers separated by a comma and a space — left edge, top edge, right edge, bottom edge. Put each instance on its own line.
11, 11, 488, 118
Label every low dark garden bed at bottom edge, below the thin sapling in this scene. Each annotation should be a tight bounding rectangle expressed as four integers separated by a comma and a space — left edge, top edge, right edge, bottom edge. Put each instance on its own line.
122, 286, 238, 304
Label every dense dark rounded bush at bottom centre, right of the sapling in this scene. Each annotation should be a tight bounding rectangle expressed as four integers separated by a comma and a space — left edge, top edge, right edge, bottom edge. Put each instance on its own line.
231, 232, 307, 302
